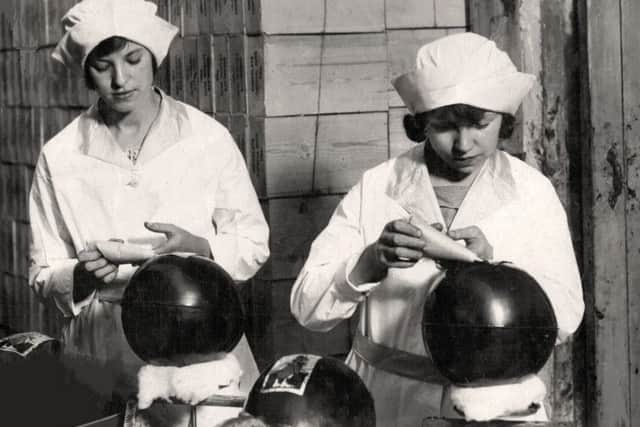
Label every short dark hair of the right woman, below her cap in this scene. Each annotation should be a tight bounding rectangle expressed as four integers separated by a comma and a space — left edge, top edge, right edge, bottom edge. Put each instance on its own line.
402, 104, 516, 142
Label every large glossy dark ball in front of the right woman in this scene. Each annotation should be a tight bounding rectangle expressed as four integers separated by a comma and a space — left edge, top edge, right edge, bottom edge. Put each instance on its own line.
422, 262, 558, 385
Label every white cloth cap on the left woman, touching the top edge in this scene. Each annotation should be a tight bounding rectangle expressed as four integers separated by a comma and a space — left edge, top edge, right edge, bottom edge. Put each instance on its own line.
51, 0, 178, 71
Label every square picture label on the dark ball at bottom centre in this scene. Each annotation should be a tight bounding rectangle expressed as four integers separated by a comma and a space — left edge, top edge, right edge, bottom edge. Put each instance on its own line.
260, 354, 321, 396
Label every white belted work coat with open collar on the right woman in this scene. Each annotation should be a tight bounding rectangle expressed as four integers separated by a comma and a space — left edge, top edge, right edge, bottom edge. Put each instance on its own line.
291, 144, 584, 427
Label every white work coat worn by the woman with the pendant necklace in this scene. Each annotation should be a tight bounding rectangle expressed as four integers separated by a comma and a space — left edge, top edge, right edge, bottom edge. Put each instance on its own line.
29, 91, 269, 425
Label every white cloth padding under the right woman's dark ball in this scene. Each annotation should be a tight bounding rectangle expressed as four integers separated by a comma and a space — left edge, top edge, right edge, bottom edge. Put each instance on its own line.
446, 375, 547, 421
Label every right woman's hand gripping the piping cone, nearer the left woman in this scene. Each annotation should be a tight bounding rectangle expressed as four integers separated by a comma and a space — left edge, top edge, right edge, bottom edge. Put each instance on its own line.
349, 219, 436, 284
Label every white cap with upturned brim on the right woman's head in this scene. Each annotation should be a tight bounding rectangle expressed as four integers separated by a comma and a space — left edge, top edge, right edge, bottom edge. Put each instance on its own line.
392, 32, 535, 114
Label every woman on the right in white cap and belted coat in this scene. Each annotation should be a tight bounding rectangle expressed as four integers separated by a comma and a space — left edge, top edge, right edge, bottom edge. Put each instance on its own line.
291, 33, 584, 427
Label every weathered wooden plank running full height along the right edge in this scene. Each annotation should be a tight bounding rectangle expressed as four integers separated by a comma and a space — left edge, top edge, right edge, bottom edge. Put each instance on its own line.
580, 0, 640, 426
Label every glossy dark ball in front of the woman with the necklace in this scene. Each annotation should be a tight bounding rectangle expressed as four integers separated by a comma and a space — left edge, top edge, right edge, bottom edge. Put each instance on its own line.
121, 254, 244, 366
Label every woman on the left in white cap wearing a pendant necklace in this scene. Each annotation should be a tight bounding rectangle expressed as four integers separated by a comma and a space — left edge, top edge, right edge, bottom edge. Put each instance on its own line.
29, 0, 269, 425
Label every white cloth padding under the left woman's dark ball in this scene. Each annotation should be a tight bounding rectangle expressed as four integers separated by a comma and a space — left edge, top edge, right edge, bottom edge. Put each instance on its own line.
138, 353, 242, 409
